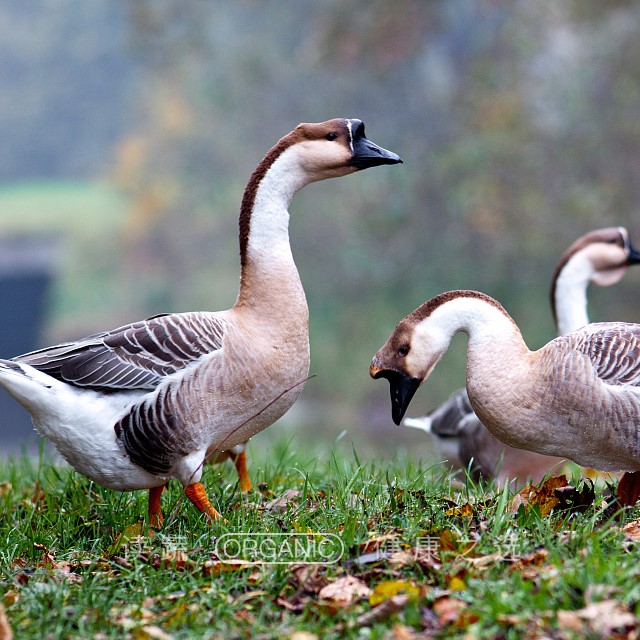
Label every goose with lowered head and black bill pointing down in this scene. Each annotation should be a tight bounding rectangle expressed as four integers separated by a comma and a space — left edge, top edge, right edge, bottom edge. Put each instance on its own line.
369, 290, 640, 504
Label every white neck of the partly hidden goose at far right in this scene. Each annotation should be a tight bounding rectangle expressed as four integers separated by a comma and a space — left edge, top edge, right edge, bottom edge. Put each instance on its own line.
552, 254, 593, 335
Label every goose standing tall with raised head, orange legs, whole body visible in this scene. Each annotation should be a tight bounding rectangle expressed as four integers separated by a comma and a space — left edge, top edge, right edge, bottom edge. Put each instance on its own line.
0, 118, 402, 526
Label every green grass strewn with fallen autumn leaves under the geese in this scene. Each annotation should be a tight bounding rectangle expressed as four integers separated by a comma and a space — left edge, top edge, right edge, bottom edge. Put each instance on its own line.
0, 446, 640, 639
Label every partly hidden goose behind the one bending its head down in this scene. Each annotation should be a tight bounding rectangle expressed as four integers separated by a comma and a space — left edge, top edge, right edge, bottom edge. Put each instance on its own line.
402, 227, 640, 485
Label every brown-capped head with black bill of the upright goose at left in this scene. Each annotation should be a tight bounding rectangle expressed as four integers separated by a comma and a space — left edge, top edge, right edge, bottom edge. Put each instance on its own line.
285, 118, 402, 182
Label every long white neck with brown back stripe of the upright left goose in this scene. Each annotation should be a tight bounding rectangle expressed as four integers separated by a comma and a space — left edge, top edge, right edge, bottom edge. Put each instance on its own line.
236, 146, 310, 310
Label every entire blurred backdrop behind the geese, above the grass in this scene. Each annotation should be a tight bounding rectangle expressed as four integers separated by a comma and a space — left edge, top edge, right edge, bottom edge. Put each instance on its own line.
0, 0, 640, 455
